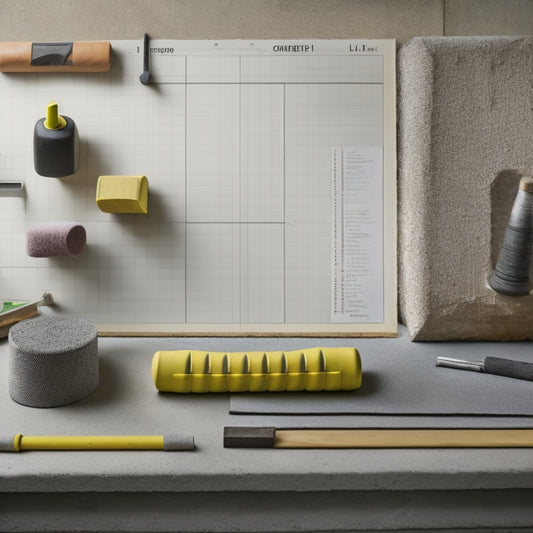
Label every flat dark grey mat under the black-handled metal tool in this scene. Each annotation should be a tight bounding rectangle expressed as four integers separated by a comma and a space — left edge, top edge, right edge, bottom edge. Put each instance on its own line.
230, 332, 533, 417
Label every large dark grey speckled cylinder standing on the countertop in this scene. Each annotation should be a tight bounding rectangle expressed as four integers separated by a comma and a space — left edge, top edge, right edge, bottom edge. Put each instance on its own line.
9, 315, 99, 407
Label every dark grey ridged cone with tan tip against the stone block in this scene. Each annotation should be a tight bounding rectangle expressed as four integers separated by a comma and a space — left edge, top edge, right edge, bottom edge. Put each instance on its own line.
489, 177, 533, 296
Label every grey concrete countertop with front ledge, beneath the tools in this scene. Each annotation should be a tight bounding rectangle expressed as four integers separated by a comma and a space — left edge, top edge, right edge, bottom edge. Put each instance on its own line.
0, 329, 533, 531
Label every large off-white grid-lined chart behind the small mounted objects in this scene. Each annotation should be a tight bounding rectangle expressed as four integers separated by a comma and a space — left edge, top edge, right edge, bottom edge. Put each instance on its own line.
0, 40, 396, 335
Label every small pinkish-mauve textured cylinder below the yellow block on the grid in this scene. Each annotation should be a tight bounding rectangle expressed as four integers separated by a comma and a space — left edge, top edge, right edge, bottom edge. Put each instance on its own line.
26, 222, 87, 257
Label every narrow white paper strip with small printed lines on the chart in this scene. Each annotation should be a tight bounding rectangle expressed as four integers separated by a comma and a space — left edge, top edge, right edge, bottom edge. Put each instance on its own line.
331, 146, 384, 323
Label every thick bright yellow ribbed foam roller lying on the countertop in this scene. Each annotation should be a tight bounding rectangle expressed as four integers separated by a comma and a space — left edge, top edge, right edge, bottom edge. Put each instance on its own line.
152, 348, 362, 393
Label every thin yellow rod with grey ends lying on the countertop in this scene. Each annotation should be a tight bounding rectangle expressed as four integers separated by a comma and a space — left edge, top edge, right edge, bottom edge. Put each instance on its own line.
0, 433, 195, 452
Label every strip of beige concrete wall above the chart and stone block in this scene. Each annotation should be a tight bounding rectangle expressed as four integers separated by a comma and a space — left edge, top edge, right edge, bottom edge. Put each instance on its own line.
0, 0, 533, 44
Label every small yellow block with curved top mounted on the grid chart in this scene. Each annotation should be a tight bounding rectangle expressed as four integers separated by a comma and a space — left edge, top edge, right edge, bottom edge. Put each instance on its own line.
96, 176, 148, 214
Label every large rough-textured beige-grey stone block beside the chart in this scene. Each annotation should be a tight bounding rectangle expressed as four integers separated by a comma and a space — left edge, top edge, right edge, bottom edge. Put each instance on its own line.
398, 36, 533, 340
